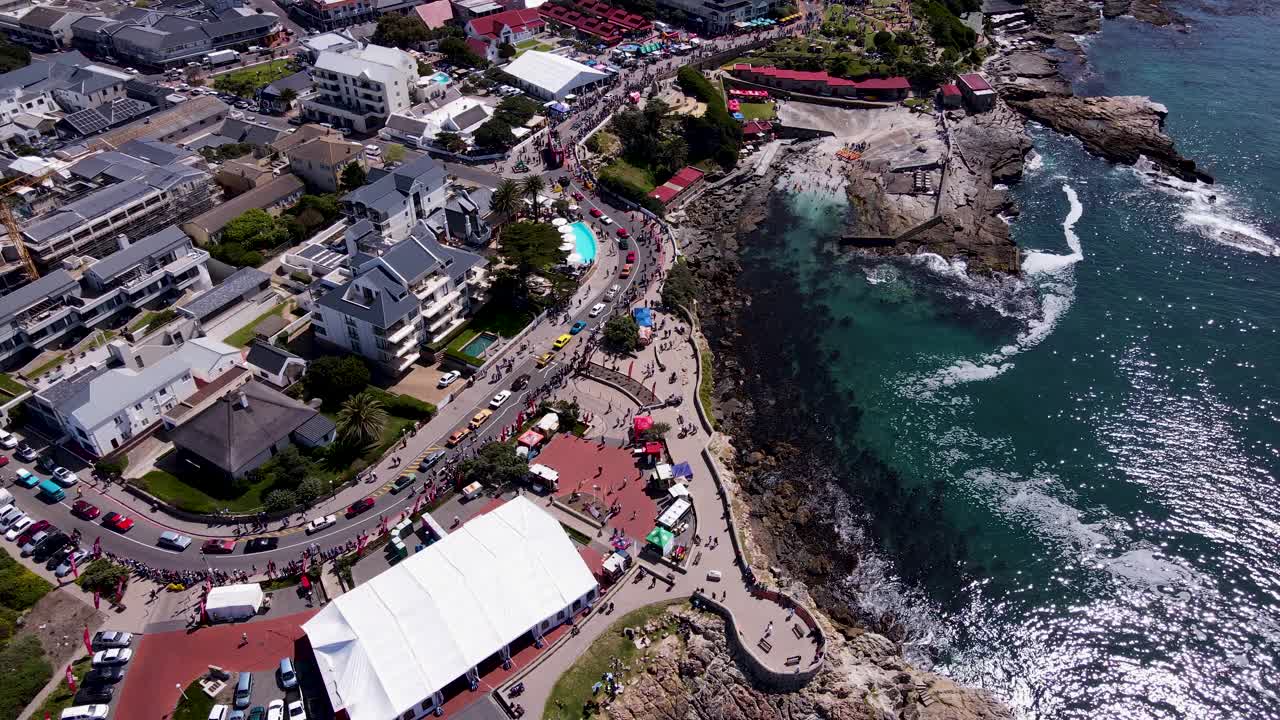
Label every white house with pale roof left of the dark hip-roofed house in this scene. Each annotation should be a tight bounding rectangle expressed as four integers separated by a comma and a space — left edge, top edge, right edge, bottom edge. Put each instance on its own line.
27, 338, 241, 457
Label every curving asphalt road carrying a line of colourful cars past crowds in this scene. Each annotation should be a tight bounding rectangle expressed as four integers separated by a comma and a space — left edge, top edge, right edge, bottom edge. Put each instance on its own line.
0, 176, 657, 571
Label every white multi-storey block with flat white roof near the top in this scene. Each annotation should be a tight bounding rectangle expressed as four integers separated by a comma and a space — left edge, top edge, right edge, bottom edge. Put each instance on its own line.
302, 45, 417, 132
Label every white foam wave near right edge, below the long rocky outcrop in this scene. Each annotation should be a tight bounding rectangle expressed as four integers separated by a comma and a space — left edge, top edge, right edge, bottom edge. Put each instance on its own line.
1133, 158, 1280, 258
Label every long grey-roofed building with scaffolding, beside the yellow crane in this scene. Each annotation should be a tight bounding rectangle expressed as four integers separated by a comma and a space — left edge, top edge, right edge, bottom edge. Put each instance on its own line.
15, 141, 216, 269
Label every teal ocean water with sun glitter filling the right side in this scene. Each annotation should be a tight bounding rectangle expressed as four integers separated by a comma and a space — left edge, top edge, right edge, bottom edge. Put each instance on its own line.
739, 0, 1280, 720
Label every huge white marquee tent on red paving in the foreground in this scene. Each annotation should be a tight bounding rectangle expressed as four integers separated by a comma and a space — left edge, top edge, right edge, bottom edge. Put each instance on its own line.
302, 496, 598, 720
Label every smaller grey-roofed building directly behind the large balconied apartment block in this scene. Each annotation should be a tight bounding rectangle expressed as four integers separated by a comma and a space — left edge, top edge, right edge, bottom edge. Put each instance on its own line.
342, 155, 448, 242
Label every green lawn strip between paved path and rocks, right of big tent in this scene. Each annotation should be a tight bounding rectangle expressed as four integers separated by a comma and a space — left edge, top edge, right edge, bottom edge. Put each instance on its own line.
543, 602, 676, 720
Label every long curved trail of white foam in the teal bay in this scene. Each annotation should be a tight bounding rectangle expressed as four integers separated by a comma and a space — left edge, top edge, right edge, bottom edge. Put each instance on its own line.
901, 184, 1084, 400
